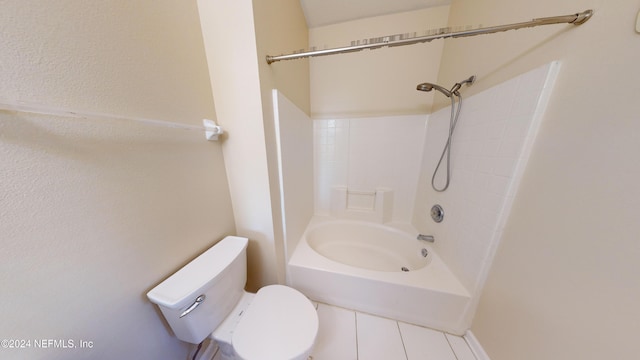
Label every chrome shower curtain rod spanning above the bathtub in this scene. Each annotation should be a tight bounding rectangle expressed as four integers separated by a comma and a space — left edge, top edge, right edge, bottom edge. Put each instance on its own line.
267, 9, 593, 64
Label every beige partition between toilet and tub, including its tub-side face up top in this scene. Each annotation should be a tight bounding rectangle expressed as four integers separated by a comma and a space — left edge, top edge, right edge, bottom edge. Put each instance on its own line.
198, 0, 309, 291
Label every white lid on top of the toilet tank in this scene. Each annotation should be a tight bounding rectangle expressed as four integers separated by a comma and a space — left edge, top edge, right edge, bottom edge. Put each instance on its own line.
147, 236, 249, 309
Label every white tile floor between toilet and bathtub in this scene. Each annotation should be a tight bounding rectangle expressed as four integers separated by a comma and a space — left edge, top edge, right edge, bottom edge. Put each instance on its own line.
213, 304, 476, 360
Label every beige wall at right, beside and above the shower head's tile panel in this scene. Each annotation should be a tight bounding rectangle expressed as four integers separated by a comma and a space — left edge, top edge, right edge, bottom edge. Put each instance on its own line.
439, 0, 640, 360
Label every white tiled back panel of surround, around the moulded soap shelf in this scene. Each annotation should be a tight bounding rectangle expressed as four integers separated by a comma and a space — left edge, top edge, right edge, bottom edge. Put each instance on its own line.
314, 115, 427, 222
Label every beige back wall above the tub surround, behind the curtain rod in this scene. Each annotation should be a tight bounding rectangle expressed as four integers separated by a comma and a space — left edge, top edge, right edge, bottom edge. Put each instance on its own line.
309, 6, 449, 118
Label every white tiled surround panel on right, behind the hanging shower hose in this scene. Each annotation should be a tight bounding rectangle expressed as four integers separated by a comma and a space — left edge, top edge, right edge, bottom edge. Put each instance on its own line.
413, 63, 559, 294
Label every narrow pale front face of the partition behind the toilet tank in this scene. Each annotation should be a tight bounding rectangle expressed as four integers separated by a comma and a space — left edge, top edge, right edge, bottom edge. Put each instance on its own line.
198, 0, 278, 291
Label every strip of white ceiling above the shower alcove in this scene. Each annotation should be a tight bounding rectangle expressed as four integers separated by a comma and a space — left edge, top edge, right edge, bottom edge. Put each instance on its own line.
300, 0, 451, 28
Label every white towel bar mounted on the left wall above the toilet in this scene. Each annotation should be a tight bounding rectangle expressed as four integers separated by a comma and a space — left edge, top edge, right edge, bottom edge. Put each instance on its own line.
0, 99, 224, 140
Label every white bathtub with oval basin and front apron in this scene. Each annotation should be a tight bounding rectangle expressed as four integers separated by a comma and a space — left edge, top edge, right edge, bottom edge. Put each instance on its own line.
287, 216, 470, 335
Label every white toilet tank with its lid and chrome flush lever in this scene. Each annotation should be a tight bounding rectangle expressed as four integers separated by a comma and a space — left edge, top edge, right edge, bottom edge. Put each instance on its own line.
147, 236, 249, 344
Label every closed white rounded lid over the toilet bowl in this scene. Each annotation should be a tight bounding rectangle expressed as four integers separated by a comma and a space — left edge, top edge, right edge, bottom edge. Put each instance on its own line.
231, 285, 318, 360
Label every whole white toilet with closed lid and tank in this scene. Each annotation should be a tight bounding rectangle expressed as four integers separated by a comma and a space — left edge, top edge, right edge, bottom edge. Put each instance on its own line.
147, 236, 318, 360
